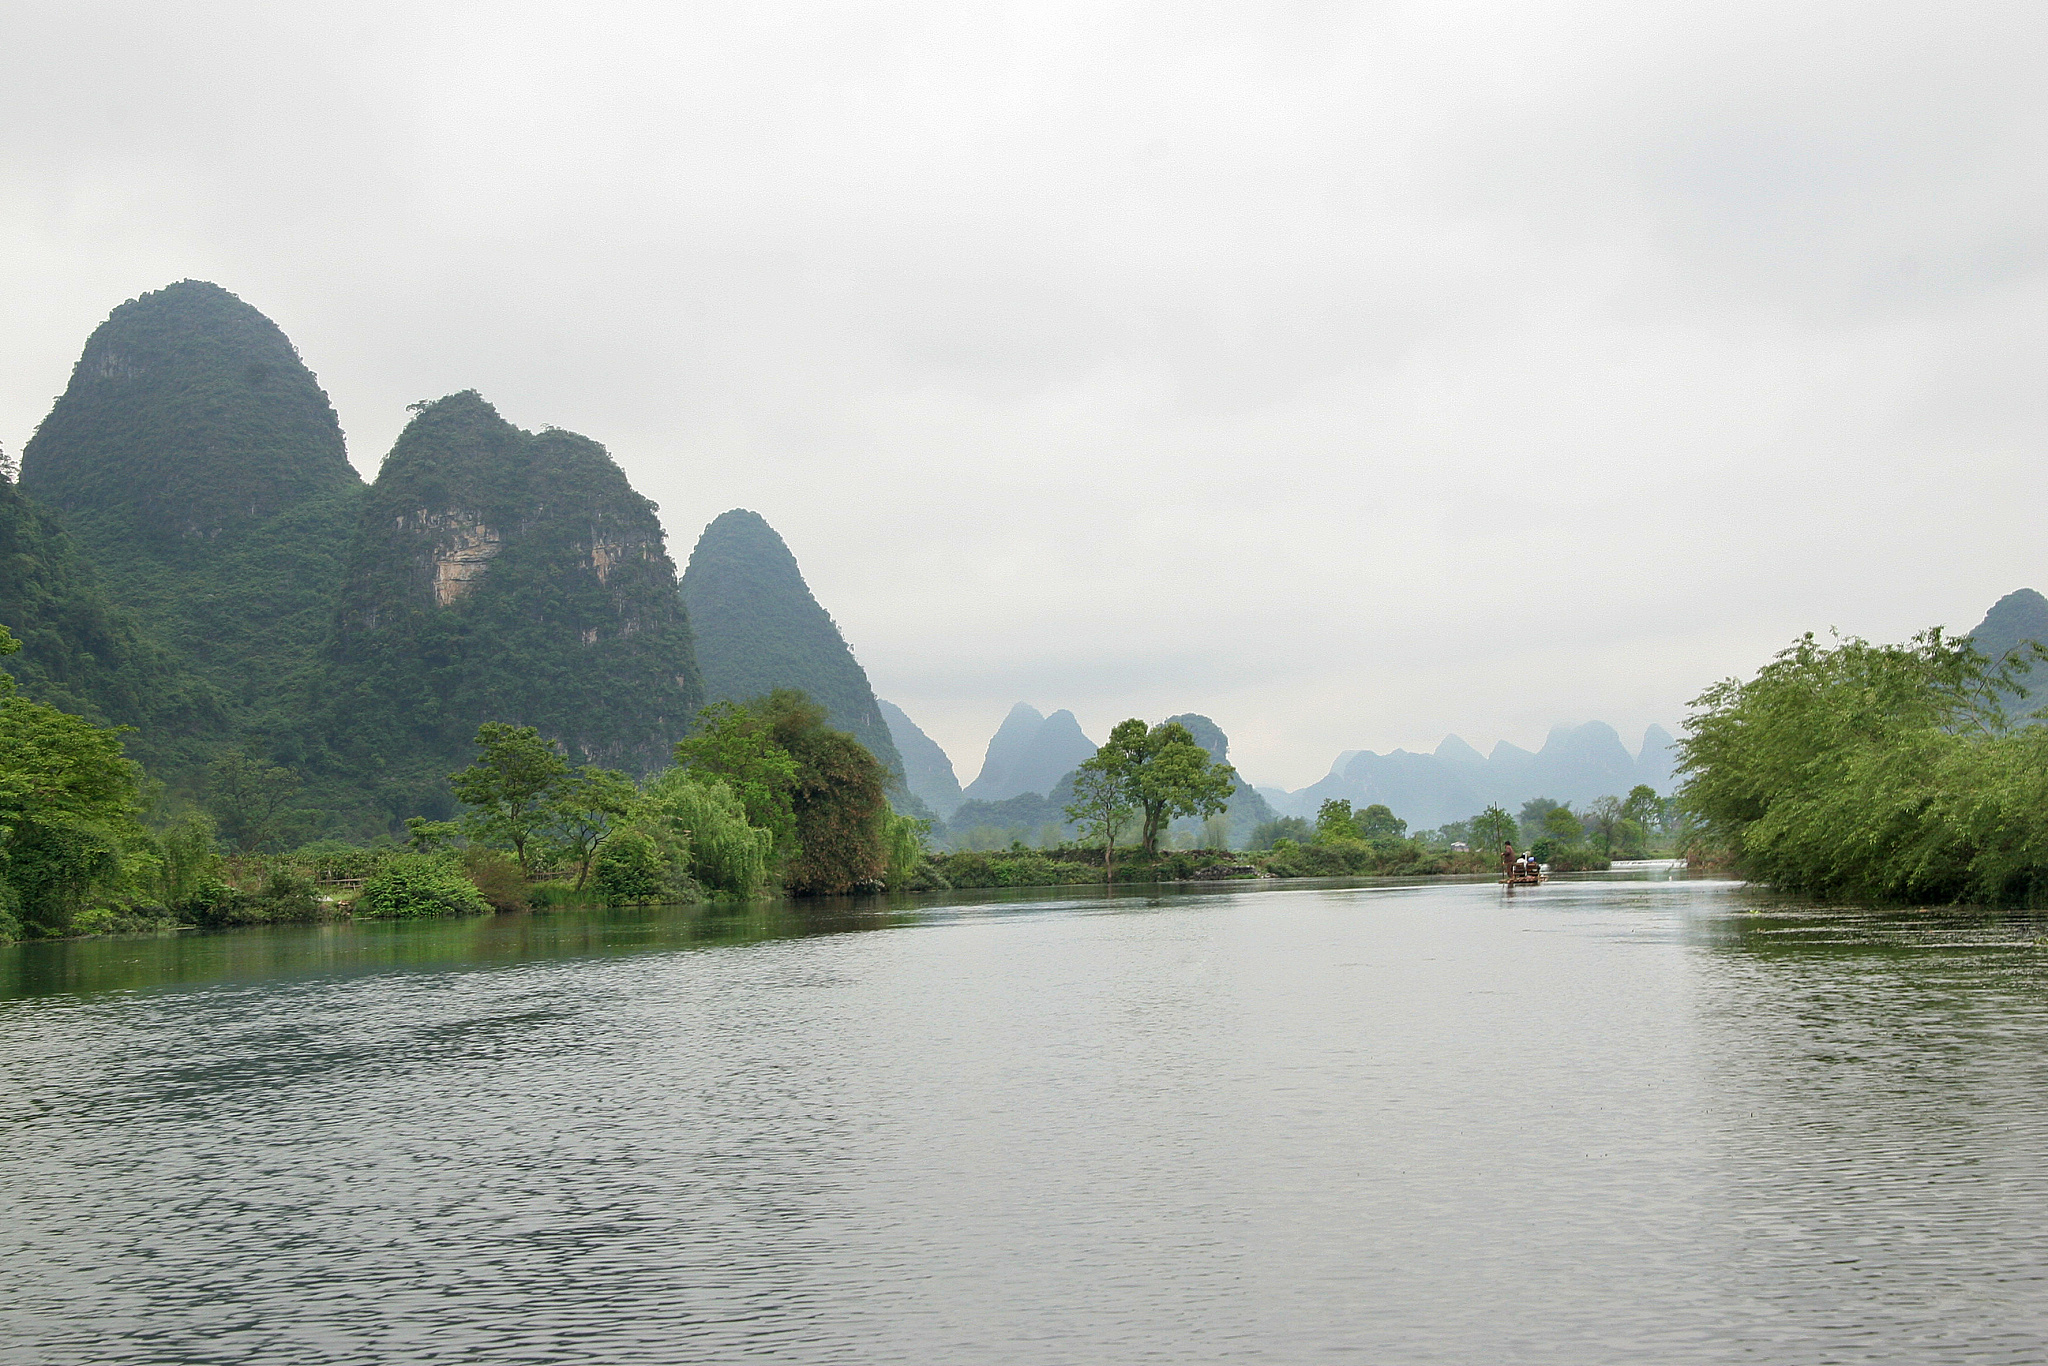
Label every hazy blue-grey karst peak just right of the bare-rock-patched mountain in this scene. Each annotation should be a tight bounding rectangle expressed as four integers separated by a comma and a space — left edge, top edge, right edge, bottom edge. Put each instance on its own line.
682, 508, 903, 778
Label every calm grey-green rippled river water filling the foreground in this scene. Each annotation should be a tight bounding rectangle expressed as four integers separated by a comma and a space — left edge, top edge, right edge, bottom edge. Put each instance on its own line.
0, 874, 2048, 1366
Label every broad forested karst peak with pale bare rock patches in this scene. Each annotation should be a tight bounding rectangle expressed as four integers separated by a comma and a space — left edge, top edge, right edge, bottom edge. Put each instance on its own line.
328, 393, 705, 813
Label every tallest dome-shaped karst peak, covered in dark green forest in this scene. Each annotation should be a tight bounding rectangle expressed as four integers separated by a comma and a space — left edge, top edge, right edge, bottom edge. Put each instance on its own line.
20, 281, 362, 727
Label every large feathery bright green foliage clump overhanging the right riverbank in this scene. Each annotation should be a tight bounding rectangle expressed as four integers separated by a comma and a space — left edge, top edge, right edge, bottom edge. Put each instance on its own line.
1679, 629, 2048, 905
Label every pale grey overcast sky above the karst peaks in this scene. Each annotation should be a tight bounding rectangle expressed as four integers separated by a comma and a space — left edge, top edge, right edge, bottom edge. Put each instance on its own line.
0, 0, 2048, 786
